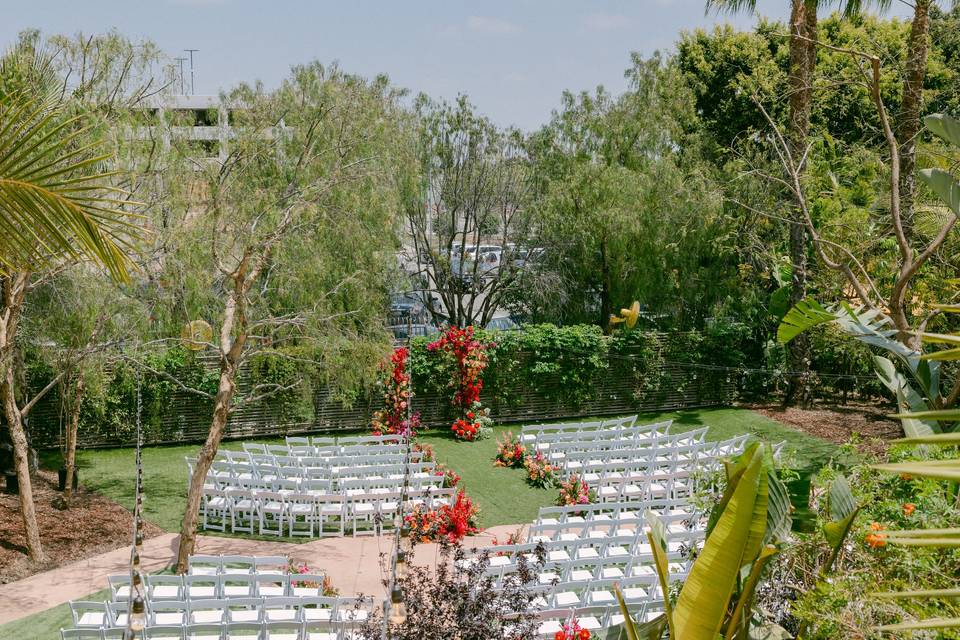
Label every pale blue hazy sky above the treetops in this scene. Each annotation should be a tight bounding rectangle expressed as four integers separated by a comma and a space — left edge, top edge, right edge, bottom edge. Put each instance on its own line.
0, 0, 908, 131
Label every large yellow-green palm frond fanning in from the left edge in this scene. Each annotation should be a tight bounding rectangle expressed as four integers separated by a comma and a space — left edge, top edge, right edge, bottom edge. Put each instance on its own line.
0, 83, 143, 280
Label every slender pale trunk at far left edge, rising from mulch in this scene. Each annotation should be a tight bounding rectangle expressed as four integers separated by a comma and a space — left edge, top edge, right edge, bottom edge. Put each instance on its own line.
0, 272, 45, 562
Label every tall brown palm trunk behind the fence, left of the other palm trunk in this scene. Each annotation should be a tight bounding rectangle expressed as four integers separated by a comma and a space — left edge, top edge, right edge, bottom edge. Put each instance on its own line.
784, 0, 817, 406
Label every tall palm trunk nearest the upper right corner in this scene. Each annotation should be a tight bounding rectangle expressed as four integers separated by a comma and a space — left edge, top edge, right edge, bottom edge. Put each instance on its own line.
897, 0, 930, 245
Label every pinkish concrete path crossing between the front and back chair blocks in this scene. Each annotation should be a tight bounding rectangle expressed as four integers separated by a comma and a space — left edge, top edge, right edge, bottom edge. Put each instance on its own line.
0, 525, 520, 624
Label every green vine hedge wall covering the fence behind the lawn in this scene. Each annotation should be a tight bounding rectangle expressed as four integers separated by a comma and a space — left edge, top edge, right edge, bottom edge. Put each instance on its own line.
16, 324, 884, 448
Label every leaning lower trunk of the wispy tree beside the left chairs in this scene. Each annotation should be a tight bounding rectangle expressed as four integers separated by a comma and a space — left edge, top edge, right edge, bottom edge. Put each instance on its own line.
177, 358, 237, 574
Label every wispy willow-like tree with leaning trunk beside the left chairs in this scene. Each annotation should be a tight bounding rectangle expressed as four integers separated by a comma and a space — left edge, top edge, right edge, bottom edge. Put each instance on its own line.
120, 63, 403, 573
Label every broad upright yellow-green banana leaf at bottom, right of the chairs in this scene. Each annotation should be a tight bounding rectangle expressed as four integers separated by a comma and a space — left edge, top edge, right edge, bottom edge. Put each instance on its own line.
671, 447, 767, 640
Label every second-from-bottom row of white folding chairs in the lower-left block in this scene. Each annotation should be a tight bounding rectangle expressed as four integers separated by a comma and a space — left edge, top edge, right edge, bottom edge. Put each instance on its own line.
69, 595, 372, 629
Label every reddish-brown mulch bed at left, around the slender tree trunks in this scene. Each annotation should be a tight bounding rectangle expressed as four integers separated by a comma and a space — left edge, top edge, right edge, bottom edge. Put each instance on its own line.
0, 471, 163, 584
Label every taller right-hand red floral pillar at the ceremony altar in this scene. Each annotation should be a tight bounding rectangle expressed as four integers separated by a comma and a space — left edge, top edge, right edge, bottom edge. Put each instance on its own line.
427, 327, 494, 442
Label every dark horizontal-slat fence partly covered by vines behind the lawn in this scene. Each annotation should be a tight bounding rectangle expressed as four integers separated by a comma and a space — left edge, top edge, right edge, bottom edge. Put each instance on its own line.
28, 354, 737, 449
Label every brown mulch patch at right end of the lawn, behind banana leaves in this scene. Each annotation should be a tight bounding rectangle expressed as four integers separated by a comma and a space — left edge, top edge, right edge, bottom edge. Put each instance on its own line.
747, 404, 903, 455
